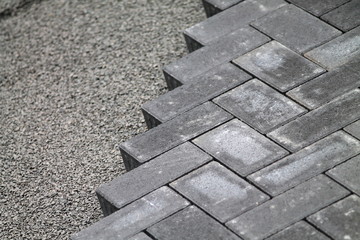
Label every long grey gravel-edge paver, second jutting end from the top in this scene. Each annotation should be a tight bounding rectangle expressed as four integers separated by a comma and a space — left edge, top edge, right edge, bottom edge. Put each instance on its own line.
184, 0, 287, 51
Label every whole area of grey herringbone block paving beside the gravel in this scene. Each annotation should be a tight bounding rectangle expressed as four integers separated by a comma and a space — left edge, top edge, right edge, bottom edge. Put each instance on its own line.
73, 0, 360, 240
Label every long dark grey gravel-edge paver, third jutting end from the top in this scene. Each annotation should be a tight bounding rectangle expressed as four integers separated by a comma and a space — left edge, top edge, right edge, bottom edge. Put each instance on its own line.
163, 27, 270, 90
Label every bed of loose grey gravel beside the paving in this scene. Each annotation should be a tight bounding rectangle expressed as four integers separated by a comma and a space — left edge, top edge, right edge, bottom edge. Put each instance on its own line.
0, 0, 205, 240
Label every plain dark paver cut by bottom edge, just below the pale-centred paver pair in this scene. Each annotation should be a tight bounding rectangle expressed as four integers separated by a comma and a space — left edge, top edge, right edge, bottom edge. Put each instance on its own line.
147, 206, 240, 240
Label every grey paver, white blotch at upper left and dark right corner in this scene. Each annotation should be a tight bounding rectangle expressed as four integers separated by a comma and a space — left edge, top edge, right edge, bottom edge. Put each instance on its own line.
233, 41, 325, 92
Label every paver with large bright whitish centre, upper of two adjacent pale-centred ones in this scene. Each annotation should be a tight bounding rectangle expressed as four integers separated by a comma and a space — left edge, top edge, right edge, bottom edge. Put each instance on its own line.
193, 119, 288, 176
